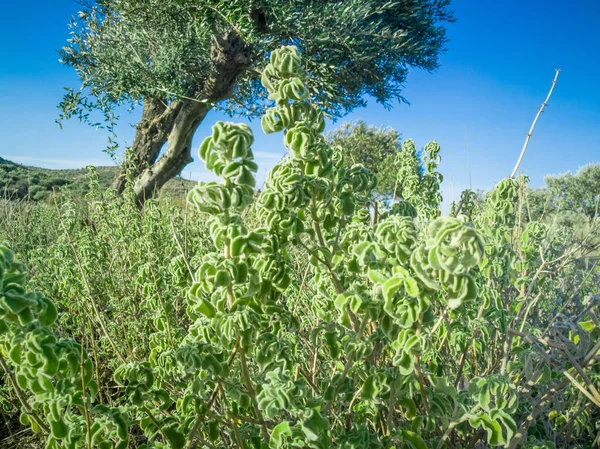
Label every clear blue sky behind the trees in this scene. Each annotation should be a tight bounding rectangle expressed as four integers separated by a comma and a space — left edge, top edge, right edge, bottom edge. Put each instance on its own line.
0, 0, 600, 201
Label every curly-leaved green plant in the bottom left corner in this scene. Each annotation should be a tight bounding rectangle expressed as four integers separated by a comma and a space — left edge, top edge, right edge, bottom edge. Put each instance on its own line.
0, 245, 129, 449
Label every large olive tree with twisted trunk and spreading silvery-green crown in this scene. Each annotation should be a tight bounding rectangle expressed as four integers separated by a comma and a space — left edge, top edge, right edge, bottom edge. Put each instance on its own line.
59, 0, 453, 203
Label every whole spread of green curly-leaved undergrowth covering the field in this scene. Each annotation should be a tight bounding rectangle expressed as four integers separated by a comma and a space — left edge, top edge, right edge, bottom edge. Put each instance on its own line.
0, 47, 600, 449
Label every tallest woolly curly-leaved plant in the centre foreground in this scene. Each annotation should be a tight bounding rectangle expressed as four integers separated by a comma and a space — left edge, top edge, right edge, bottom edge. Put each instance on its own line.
180, 47, 514, 447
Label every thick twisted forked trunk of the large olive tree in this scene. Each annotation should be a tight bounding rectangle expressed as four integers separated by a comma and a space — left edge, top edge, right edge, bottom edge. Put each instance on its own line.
112, 27, 251, 206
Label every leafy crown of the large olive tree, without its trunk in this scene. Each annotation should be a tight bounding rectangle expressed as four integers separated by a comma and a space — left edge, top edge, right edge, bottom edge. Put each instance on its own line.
61, 0, 453, 123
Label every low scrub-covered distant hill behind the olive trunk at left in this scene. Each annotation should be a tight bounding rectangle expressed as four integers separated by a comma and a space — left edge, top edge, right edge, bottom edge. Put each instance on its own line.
0, 157, 196, 201
